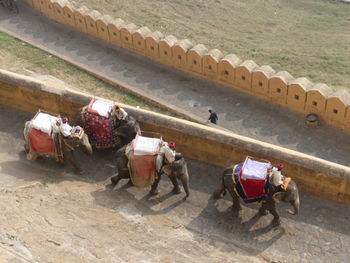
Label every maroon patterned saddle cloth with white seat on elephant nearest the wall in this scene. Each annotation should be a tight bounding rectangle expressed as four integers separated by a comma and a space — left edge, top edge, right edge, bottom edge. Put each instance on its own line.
81, 99, 118, 148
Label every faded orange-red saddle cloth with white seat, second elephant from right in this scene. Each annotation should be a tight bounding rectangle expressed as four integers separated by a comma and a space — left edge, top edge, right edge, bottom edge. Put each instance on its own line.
128, 135, 161, 188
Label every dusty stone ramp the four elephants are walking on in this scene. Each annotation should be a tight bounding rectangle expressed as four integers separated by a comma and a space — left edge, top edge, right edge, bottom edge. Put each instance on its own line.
0, 105, 350, 263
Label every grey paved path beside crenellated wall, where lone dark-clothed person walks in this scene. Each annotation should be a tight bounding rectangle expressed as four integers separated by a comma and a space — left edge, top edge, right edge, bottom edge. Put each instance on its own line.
0, 1, 350, 166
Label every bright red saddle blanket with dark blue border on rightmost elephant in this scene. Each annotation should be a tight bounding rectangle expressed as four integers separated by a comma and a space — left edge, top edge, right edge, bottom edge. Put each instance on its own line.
232, 163, 270, 203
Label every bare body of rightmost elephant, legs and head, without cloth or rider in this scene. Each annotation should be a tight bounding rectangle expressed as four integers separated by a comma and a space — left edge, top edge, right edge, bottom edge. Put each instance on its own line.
213, 166, 300, 226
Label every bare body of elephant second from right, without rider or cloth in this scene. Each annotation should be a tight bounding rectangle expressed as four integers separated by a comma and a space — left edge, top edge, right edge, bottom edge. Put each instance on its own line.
111, 146, 190, 200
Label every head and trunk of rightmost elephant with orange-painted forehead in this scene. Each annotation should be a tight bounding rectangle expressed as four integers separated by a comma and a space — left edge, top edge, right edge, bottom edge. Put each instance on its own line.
273, 180, 300, 215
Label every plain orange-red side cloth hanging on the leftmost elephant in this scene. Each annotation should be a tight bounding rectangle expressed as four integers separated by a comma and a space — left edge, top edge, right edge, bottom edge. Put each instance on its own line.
28, 128, 56, 154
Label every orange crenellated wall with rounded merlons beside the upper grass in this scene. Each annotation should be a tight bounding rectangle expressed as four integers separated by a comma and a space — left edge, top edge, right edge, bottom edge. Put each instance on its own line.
26, 0, 350, 131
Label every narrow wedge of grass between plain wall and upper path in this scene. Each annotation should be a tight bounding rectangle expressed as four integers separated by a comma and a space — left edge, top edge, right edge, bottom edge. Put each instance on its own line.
0, 32, 176, 116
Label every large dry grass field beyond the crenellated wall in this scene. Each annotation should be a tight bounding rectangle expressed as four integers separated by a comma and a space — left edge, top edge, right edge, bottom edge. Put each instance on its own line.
73, 0, 350, 89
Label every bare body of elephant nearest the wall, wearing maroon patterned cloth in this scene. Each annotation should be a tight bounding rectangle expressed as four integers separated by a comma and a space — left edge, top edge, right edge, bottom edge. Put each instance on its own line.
76, 107, 140, 149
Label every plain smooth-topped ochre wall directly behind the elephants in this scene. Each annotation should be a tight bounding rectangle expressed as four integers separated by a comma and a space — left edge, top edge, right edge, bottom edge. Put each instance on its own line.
0, 70, 350, 204
